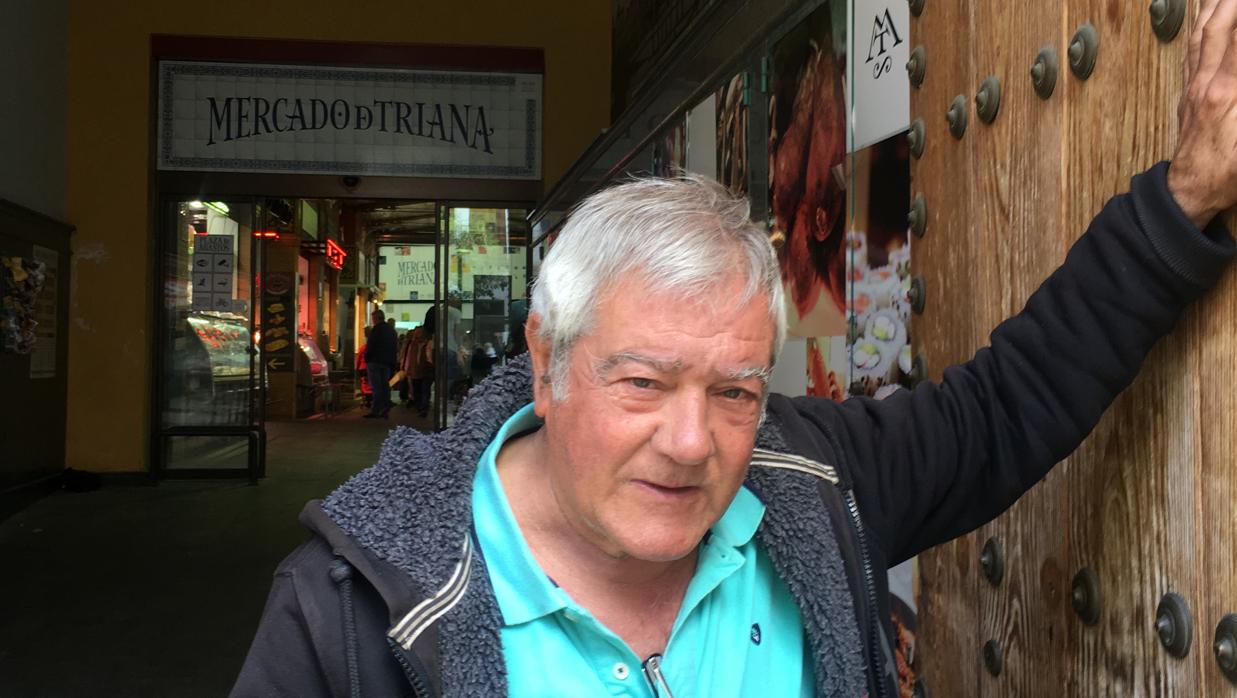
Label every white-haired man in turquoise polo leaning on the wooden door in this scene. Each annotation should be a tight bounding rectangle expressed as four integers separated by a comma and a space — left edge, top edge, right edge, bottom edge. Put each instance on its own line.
235, 0, 1237, 698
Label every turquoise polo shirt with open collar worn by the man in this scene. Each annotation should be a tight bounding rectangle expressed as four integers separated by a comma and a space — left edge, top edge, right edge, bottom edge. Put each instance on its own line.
473, 405, 813, 698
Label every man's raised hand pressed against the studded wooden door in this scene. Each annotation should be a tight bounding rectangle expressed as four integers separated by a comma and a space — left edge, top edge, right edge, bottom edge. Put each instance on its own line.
1168, 0, 1237, 228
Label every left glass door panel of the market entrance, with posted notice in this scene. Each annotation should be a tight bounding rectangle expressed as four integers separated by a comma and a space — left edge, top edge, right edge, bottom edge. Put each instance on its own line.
152, 199, 265, 480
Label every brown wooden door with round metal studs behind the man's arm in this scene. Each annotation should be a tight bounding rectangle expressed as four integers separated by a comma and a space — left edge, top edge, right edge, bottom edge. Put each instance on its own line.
910, 0, 1237, 697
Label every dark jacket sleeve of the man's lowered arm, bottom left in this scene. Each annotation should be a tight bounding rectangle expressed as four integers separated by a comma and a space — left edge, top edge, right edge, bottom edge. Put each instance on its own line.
231, 551, 330, 698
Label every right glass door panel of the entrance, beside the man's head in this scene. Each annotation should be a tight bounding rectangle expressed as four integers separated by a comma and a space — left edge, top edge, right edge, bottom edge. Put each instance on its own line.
434, 205, 528, 428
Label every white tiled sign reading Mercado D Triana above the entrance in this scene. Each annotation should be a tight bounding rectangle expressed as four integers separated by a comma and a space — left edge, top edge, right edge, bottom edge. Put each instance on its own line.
158, 61, 542, 179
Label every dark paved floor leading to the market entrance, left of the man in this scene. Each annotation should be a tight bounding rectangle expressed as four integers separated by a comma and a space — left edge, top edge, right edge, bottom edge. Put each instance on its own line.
0, 407, 435, 697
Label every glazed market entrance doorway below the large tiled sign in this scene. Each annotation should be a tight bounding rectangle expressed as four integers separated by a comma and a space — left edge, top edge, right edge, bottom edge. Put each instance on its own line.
152, 197, 528, 480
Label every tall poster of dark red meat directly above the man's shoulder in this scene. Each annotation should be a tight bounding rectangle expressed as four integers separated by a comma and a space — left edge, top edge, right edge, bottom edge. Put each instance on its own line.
767, 4, 849, 400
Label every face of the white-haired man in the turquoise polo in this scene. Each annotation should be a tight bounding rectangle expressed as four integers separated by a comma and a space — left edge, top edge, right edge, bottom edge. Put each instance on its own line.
531, 275, 773, 561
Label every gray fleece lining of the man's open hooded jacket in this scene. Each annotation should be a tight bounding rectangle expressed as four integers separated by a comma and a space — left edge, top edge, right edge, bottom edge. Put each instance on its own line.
322, 355, 867, 697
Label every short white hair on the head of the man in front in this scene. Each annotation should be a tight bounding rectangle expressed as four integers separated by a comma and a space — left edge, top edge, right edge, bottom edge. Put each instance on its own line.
531, 175, 785, 400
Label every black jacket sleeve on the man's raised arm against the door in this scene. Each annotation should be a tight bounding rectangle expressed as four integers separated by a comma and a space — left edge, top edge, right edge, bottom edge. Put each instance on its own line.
794, 163, 1235, 564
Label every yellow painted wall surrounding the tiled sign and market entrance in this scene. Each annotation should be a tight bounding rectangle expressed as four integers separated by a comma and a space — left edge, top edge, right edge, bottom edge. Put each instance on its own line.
66, 0, 610, 472
